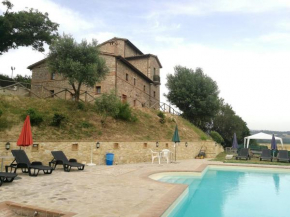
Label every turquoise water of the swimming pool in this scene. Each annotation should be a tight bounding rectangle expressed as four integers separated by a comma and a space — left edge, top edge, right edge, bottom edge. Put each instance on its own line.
159, 167, 290, 217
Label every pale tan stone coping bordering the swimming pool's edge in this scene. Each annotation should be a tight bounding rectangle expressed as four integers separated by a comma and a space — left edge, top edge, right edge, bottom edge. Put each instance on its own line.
139, 163, 290, 217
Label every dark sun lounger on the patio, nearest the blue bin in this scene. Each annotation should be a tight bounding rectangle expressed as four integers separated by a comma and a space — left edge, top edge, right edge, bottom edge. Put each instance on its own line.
49, 151, 85, 172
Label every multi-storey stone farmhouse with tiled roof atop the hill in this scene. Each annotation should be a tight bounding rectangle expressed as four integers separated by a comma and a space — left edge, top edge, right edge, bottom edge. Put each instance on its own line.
28, 38, 162, 107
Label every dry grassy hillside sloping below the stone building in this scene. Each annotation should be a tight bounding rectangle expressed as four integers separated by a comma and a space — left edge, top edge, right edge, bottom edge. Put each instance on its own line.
0, 95, 209, 141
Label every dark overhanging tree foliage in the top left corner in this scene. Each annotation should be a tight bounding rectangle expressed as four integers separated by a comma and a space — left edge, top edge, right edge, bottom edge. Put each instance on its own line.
0, 0, 59, 55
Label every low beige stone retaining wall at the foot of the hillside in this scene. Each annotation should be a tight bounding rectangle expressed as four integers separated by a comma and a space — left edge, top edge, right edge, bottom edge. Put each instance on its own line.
0, 141, 223, 165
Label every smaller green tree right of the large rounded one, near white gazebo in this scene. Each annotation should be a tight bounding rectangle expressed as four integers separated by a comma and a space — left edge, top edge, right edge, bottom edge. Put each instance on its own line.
212, 100, 250, 146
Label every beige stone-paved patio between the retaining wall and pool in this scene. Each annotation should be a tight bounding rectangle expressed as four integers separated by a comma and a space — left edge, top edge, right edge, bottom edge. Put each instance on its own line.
0, 159, 290, 217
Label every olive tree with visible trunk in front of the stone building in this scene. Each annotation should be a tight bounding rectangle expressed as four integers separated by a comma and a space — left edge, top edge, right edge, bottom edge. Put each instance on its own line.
47, 35, 109, 101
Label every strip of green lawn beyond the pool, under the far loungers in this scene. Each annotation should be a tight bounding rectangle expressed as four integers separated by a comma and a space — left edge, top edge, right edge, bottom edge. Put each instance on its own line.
212, 152, 290, 166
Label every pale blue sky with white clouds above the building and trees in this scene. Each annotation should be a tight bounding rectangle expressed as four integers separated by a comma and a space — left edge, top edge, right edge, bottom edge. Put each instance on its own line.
0, 0, 290, 131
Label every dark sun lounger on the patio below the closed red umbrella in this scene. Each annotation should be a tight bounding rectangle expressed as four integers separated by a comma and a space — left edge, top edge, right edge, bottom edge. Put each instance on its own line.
5, 150, 53, 176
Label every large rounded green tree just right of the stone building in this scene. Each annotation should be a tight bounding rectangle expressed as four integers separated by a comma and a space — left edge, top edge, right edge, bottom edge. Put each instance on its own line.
165, 66, 219, 130
